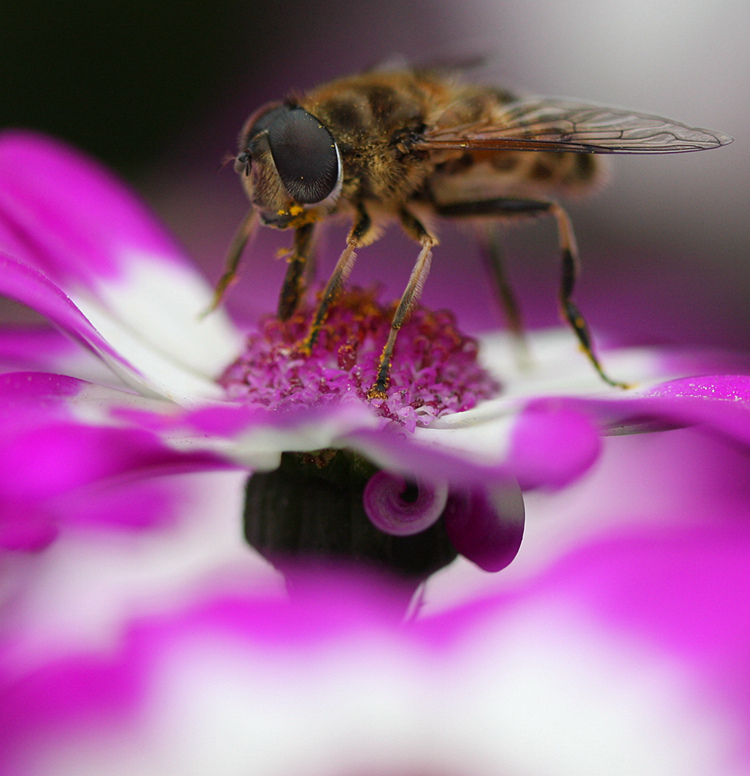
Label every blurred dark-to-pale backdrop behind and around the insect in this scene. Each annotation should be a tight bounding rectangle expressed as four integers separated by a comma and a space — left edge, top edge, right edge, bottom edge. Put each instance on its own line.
0, 0, 750, 347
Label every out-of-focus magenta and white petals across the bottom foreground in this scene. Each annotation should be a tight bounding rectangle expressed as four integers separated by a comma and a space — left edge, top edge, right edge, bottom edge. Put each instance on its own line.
0, 526, 750, 776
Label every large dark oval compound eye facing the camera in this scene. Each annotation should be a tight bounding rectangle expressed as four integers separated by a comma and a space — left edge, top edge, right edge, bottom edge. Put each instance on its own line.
268, 106, 339, 205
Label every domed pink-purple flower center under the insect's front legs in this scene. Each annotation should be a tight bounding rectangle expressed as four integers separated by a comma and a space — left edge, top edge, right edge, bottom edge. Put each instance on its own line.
219, 288, 500, 429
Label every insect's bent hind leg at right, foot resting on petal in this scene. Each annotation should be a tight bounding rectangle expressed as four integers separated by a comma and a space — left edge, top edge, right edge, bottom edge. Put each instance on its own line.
435, 198, 628, 388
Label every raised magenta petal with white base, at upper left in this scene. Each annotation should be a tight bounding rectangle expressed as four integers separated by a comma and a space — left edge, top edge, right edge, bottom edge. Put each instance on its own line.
0, 132, 238, 394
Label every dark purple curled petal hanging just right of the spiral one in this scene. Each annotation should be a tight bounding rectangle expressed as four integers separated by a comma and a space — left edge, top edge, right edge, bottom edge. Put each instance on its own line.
443, 481, 524, 571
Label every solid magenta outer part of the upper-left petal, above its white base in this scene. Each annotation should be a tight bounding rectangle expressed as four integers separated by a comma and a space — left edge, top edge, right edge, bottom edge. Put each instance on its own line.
0, 131, 184, 291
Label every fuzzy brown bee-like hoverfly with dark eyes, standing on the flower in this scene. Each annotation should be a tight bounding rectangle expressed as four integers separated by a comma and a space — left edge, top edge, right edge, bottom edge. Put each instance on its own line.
214, 69, 732, 398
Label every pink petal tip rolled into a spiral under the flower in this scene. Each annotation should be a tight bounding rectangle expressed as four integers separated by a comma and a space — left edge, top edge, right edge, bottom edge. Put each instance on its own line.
362, 471, 448, 536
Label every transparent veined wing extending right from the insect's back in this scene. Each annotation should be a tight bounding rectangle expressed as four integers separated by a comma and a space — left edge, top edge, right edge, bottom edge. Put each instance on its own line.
415, 99, 732, 154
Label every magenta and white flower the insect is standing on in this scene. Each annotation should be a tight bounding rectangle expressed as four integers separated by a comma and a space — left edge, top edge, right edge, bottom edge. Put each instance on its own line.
0, 127, 748, 578
